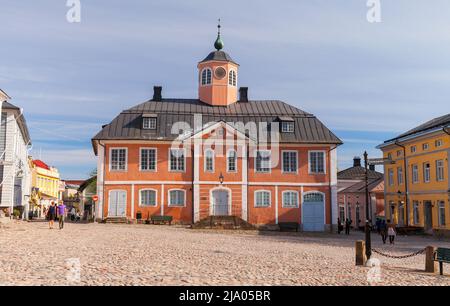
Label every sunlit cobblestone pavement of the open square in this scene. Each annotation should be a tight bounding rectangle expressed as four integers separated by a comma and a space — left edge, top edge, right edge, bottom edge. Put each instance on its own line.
0, 222, 450, 285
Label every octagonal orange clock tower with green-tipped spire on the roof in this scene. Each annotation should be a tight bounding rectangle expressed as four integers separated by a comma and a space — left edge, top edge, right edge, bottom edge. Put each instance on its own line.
197, 20, 239, 106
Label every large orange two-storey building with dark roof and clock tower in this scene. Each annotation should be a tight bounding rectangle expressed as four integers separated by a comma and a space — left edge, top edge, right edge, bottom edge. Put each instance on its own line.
92, 27, 341, 231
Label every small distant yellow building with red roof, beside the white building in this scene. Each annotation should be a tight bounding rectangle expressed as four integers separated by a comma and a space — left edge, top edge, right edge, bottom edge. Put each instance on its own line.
30, 158, 60, 216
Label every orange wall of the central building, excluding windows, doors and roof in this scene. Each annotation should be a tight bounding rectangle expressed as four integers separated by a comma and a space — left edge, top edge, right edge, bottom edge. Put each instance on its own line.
102, 141, 338, 228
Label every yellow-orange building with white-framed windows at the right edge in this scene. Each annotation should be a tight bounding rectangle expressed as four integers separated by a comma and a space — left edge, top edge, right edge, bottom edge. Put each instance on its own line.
378, 114, 450, 234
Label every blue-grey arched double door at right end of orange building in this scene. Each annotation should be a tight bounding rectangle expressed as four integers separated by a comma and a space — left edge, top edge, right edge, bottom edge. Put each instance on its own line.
302, 193, 325, 232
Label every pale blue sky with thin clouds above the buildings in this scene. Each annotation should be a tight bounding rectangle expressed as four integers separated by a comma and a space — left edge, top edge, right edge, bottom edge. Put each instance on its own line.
0, 0, 450, 179
